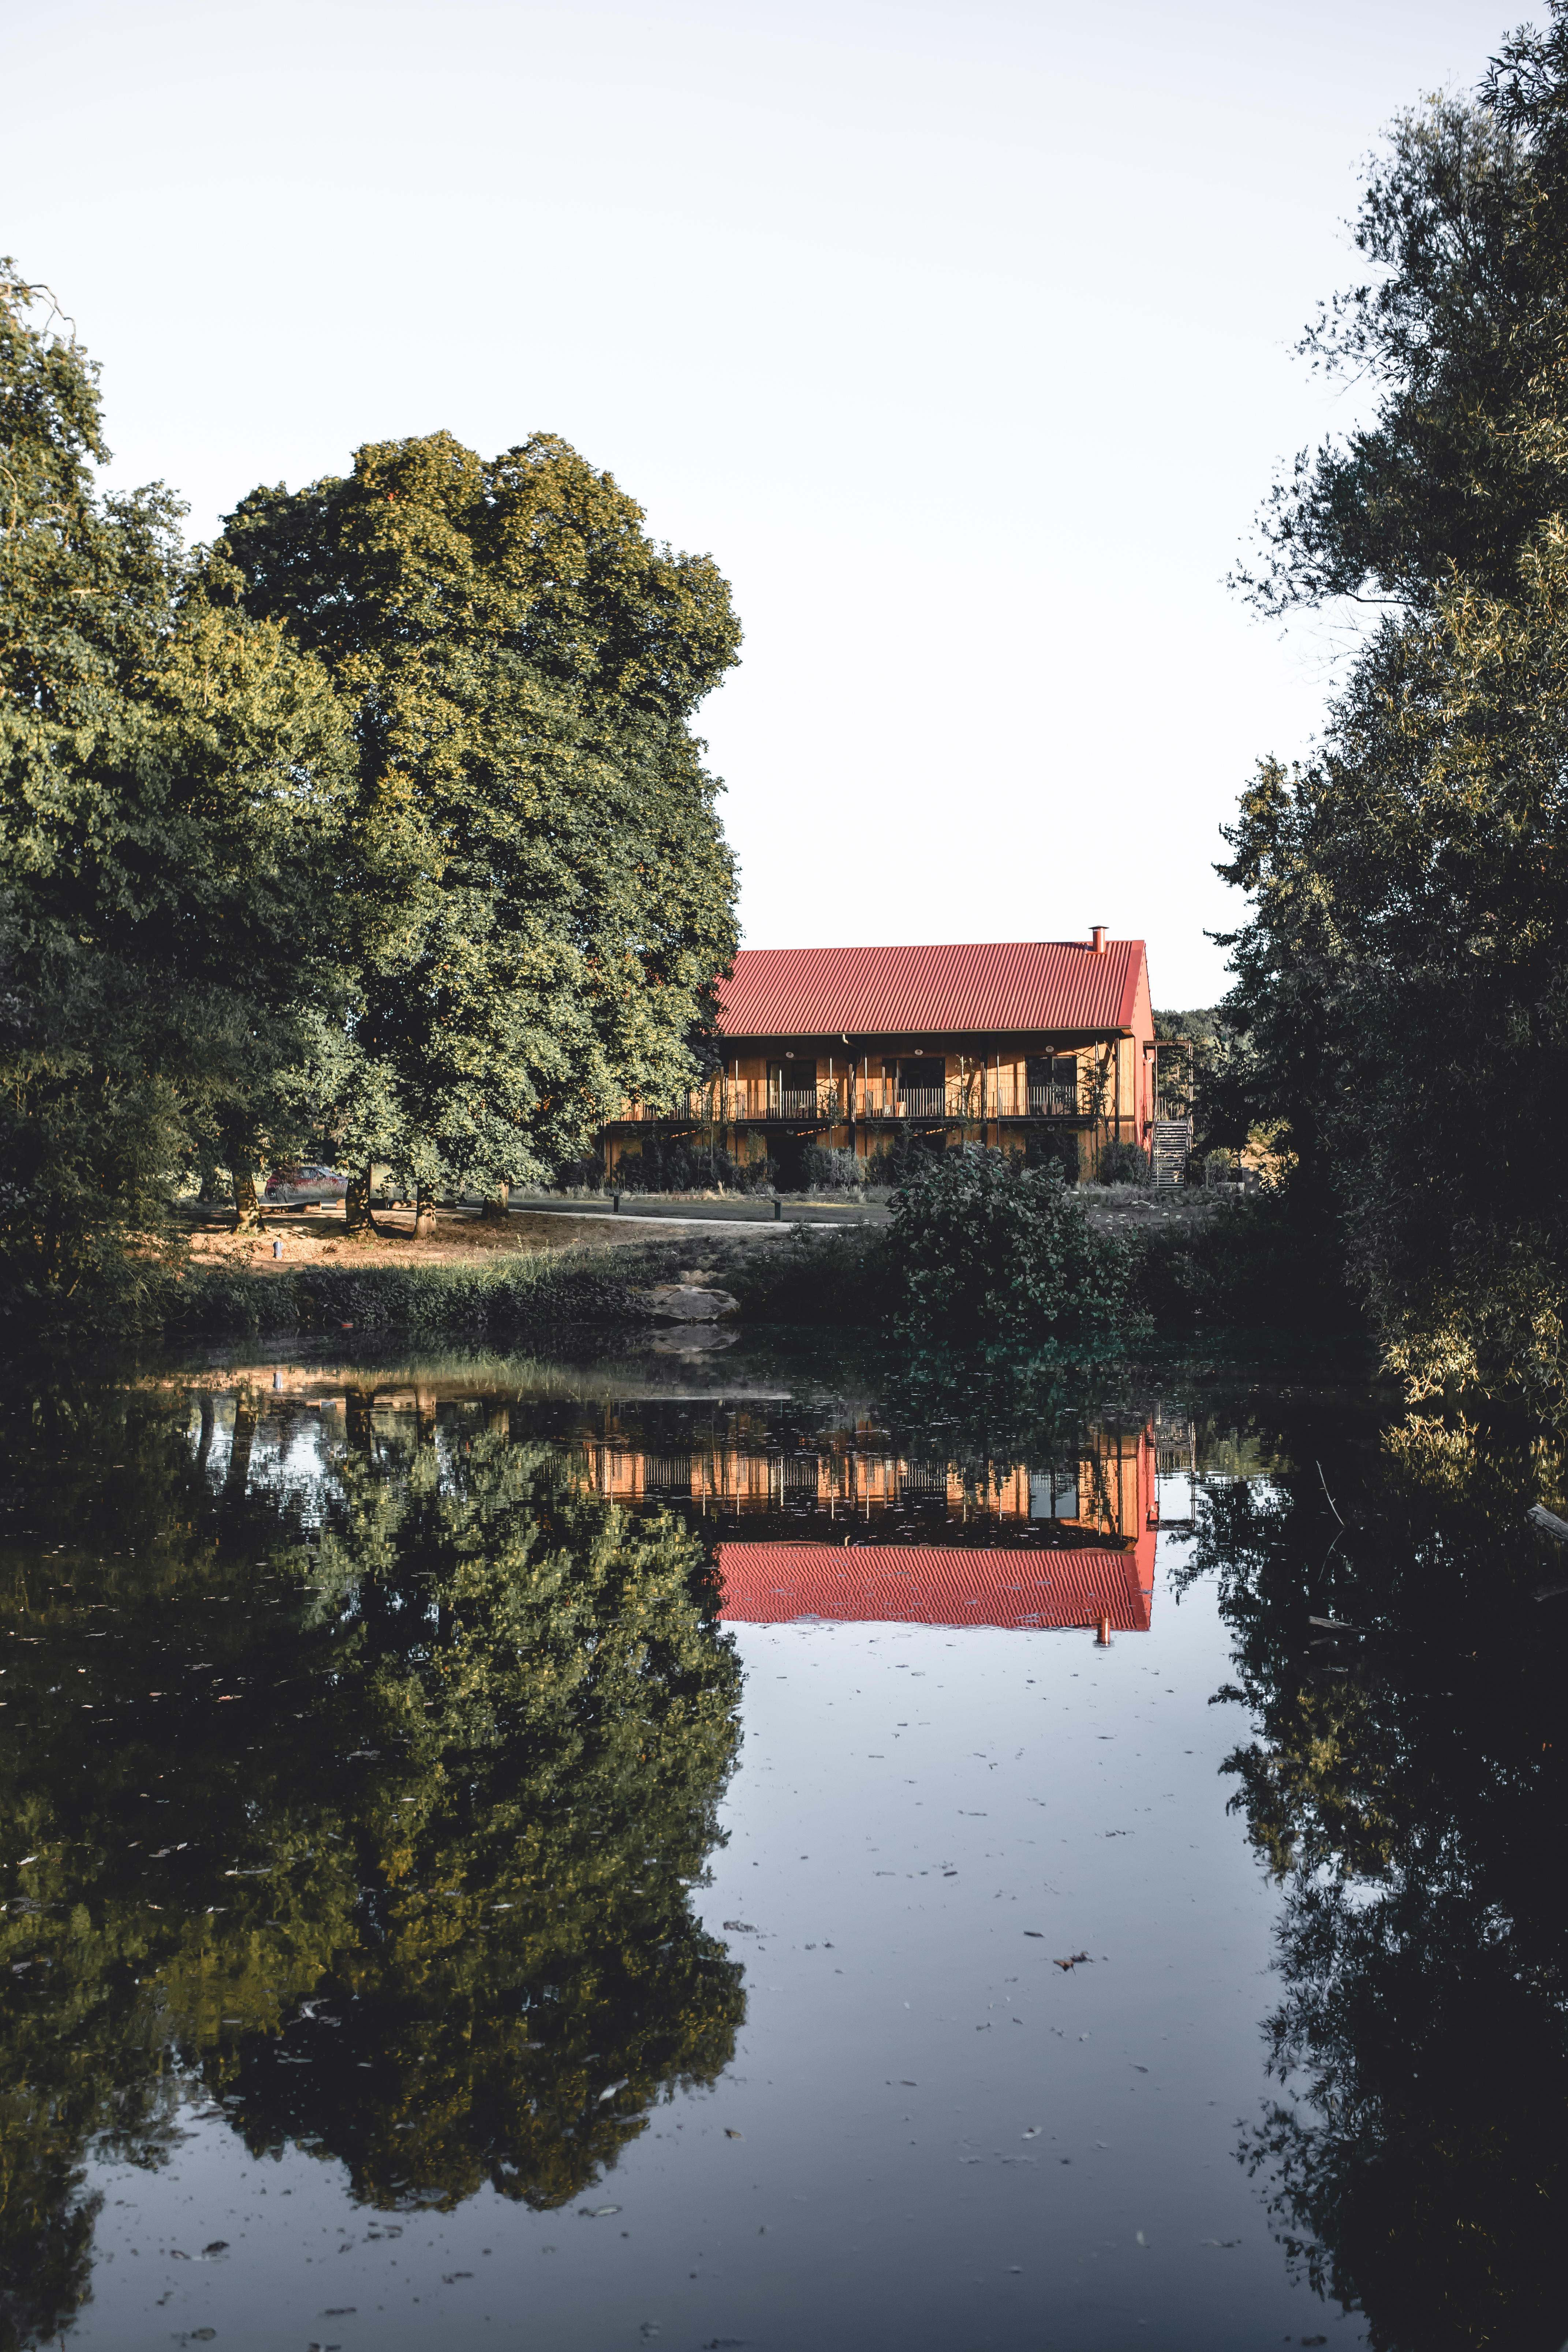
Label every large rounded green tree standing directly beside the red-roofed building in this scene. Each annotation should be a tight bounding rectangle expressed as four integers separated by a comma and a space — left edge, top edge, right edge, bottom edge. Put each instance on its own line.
214, 433, 740, 1197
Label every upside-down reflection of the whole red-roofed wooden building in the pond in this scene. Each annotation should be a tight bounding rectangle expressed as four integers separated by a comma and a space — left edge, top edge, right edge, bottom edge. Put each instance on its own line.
578, 1425, 1159, 1635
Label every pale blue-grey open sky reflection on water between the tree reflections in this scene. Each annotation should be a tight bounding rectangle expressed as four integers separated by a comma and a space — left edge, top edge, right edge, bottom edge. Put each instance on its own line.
67, 1543, 1361, 2352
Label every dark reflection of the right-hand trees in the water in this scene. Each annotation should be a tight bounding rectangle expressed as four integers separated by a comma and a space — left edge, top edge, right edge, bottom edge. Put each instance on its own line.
1190, 1425, 1568, 2352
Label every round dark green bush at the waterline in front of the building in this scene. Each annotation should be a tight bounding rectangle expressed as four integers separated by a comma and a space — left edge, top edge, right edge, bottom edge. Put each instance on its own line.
886, 1150, 1147, 1345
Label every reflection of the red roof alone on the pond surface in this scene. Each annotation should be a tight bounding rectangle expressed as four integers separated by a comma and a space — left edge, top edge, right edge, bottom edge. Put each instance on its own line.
719, 1529, 1154, 1632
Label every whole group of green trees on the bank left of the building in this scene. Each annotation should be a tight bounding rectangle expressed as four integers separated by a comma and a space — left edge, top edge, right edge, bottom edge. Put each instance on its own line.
0, 264, 740, 1308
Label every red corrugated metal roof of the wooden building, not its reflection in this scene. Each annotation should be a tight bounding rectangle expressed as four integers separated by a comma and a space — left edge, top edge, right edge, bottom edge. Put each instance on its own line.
719, 938, 1145, 1037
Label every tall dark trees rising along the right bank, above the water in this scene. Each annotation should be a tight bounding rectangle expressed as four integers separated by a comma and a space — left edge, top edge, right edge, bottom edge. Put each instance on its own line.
1208, 0, 1568, 1411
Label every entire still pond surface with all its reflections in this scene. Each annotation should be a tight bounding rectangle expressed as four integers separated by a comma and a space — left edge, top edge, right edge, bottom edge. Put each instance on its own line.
0, 1341, 1568, 2352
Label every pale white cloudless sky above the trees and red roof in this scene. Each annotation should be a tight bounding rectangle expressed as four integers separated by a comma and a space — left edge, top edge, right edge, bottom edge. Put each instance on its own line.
0, 0, 1528, 1007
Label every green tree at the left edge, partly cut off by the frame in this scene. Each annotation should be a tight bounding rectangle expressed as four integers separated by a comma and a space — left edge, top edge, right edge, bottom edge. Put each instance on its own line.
0, 264, 357, 1303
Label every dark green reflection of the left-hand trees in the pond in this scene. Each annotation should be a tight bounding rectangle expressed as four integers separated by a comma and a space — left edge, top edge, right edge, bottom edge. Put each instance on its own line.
0, 1397, 743, 2345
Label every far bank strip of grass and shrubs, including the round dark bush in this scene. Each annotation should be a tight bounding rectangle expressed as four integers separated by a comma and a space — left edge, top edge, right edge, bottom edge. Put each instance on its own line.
141, 1160, 1361, 1362
